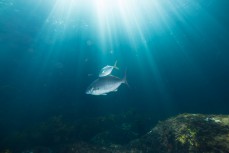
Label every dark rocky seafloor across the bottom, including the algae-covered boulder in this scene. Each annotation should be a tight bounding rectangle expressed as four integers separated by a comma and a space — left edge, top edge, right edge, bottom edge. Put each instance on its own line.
0, 114, 229, 153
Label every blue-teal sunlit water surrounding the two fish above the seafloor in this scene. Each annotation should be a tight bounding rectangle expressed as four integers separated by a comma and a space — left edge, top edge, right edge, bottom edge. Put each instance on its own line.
0, 0, 229, 151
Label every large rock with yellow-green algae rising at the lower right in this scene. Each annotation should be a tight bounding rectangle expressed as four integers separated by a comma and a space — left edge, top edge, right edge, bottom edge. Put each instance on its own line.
129, 114, 229, 153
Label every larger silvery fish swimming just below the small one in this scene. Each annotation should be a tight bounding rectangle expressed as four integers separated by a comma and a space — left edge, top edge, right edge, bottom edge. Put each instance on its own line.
85, 73, 128, 95
